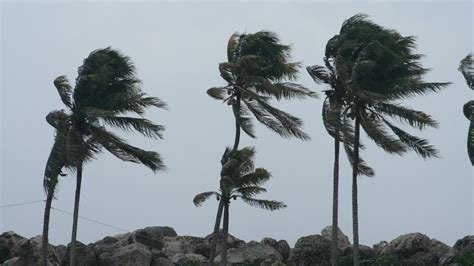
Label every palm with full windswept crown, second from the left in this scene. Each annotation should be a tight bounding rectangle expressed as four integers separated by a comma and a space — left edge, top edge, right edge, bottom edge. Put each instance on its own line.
48, 48, 166, 265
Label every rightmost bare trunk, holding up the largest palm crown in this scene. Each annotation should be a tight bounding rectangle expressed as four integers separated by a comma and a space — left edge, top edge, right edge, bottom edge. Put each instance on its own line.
352, 115, 360, 266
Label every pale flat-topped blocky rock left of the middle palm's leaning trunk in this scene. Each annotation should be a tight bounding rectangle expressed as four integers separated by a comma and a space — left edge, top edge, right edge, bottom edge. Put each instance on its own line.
163, 236, 209, 257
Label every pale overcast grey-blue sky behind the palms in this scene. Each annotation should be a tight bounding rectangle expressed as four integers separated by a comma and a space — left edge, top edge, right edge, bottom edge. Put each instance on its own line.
0, 1, 474, 245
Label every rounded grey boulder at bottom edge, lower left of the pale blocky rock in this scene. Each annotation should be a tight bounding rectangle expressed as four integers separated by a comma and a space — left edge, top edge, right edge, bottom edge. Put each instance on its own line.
110, 243, 151, 266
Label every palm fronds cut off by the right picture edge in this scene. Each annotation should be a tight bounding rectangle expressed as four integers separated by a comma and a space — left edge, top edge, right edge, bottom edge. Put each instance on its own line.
459, 54, 474, 165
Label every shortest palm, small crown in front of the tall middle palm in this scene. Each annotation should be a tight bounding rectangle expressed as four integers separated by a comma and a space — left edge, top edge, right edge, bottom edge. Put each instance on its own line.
193, 147, 286, 266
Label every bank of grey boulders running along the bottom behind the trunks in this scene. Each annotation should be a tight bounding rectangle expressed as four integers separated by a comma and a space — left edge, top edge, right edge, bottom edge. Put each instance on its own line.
0, 226, 474, 266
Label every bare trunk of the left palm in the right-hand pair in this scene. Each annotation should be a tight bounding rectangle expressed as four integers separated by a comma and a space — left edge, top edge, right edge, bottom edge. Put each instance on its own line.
331, 131, 340, 266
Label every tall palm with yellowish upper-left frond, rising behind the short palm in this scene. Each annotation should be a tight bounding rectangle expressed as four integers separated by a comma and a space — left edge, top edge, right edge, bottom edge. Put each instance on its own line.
207, 31, 316, 264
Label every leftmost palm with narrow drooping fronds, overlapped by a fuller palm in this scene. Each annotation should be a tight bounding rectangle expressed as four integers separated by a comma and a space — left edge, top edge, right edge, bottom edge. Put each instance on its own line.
41, 111, 73, 266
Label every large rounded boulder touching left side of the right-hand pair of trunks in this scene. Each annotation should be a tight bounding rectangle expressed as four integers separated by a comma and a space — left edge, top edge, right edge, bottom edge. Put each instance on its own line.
289, 235, 331, 266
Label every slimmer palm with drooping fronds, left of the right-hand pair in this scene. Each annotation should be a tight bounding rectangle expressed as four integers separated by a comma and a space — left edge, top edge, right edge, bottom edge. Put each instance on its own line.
306, 57, 374, 265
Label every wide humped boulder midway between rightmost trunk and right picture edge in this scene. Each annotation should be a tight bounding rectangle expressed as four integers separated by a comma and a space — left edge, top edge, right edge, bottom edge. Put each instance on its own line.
381, 233, 431, 259
